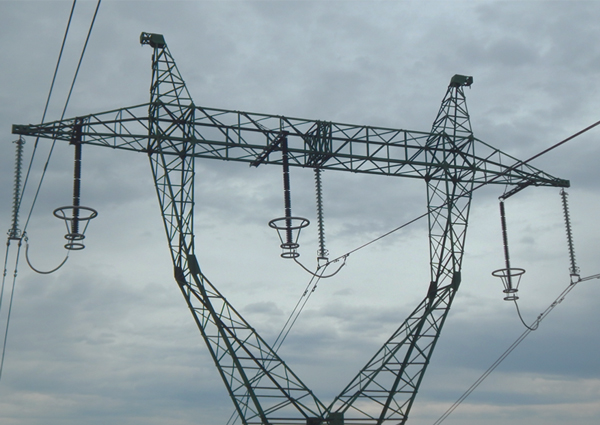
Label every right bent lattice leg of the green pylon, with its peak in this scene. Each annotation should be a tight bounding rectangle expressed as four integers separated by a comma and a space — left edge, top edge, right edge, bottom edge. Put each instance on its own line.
328, 76, 474, 425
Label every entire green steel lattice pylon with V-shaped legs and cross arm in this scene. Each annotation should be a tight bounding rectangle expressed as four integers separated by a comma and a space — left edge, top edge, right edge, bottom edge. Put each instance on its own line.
13, 33, 569, 425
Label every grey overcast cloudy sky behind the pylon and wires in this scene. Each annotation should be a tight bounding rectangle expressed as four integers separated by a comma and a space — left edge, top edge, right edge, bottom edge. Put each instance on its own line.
0, 0, 600, 425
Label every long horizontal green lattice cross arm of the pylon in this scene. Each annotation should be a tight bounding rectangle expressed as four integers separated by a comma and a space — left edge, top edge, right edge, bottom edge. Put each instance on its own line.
12, 103, 569, 187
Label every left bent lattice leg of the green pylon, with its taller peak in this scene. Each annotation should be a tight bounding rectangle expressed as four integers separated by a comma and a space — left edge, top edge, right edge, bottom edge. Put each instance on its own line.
141, 33, 325, 425
